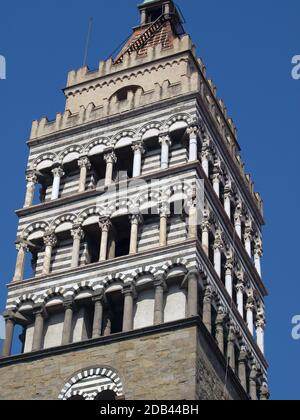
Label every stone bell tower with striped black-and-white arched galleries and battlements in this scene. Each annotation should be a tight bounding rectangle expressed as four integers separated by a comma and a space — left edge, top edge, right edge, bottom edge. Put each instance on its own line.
0, 0, 269, 400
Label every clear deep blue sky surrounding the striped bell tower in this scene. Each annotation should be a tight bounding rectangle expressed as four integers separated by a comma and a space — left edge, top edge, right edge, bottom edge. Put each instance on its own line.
0, 0, 300, 399
